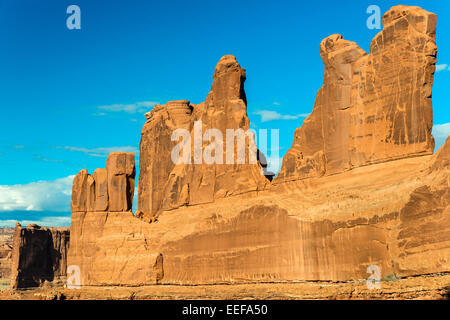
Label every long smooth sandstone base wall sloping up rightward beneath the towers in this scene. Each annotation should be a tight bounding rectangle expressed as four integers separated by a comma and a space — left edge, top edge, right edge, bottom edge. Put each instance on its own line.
69, 144, 450, 285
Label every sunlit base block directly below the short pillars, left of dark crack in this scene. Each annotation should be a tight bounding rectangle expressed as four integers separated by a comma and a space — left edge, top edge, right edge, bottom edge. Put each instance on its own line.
68, 212, 164, 286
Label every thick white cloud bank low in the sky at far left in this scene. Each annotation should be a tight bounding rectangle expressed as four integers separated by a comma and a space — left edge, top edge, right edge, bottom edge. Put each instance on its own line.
0, 175, 75, 212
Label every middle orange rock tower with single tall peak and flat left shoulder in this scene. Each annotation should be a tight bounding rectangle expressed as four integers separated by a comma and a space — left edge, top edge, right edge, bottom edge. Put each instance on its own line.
137, 55, 268, 221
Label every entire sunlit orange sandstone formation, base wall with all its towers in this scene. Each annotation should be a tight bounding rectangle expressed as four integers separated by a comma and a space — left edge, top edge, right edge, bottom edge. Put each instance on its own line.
64, 6, 450, 285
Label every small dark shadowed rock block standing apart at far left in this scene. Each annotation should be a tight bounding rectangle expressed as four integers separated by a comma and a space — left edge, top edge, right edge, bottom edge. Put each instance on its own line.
10, 224, 70, 289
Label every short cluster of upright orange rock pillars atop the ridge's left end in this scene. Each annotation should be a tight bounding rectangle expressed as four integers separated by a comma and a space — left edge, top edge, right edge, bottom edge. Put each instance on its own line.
71, 152, 136, 212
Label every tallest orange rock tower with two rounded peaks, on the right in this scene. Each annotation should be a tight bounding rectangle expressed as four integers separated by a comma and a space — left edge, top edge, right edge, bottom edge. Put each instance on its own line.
275, 6, 437, 183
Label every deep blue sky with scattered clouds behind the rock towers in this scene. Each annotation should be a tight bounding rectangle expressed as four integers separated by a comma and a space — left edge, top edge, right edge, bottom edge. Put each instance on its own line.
0, 0, 450, 226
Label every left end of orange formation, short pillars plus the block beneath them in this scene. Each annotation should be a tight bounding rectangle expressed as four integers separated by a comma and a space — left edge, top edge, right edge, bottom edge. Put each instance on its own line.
68, 152, 164, 285
